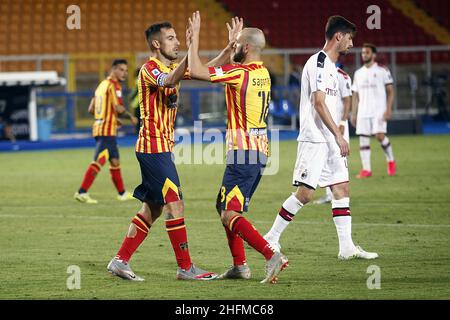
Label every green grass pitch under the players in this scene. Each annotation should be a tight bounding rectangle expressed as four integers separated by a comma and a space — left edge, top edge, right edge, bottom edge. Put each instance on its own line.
0, 136, 450, 300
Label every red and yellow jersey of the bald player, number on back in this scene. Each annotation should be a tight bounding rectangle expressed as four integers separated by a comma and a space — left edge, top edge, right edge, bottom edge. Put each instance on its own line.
209, 61, 270, 155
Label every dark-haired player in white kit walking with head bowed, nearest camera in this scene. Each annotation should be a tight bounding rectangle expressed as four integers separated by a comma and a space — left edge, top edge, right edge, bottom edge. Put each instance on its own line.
264, 16, 378, 260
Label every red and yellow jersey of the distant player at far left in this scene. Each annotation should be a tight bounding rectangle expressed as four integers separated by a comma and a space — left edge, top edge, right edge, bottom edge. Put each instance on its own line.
92, 77, 123, 137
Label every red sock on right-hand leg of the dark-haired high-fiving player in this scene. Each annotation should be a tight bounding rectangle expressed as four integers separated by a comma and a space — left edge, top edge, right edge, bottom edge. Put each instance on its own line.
166, 217, 191, 270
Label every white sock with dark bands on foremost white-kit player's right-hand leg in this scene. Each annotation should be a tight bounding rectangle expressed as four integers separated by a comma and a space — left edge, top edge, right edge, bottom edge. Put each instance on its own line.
331, 197, 355, 252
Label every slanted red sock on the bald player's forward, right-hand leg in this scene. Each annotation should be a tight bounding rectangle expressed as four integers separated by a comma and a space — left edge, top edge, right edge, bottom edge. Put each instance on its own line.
228, 215, 274, 260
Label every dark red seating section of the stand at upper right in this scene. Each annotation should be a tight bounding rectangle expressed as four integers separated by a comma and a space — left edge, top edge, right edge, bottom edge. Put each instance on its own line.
221, 0, 449, 63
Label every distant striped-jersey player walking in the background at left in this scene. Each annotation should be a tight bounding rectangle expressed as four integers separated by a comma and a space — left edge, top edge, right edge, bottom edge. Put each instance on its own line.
74, 59, 138, 204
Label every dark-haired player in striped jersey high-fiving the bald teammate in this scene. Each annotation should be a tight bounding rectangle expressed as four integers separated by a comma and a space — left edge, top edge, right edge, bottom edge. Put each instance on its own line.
107, 22, 217, 281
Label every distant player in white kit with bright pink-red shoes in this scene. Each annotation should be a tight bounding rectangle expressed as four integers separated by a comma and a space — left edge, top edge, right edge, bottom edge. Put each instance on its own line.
352, 43, 396, 178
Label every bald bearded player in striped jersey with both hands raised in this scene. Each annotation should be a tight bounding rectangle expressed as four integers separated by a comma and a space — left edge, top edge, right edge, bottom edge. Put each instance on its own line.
188, 11, 288, 283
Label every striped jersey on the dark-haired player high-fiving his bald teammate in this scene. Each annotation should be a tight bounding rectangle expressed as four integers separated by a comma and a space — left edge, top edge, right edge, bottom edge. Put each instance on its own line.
135, 57, 189, 153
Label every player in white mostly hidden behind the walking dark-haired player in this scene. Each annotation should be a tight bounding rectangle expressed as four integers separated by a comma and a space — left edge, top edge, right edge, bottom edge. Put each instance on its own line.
314, 63, 352, 204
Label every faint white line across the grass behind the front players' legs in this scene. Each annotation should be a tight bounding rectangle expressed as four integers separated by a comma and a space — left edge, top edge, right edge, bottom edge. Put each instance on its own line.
0, 214, 450, 228
